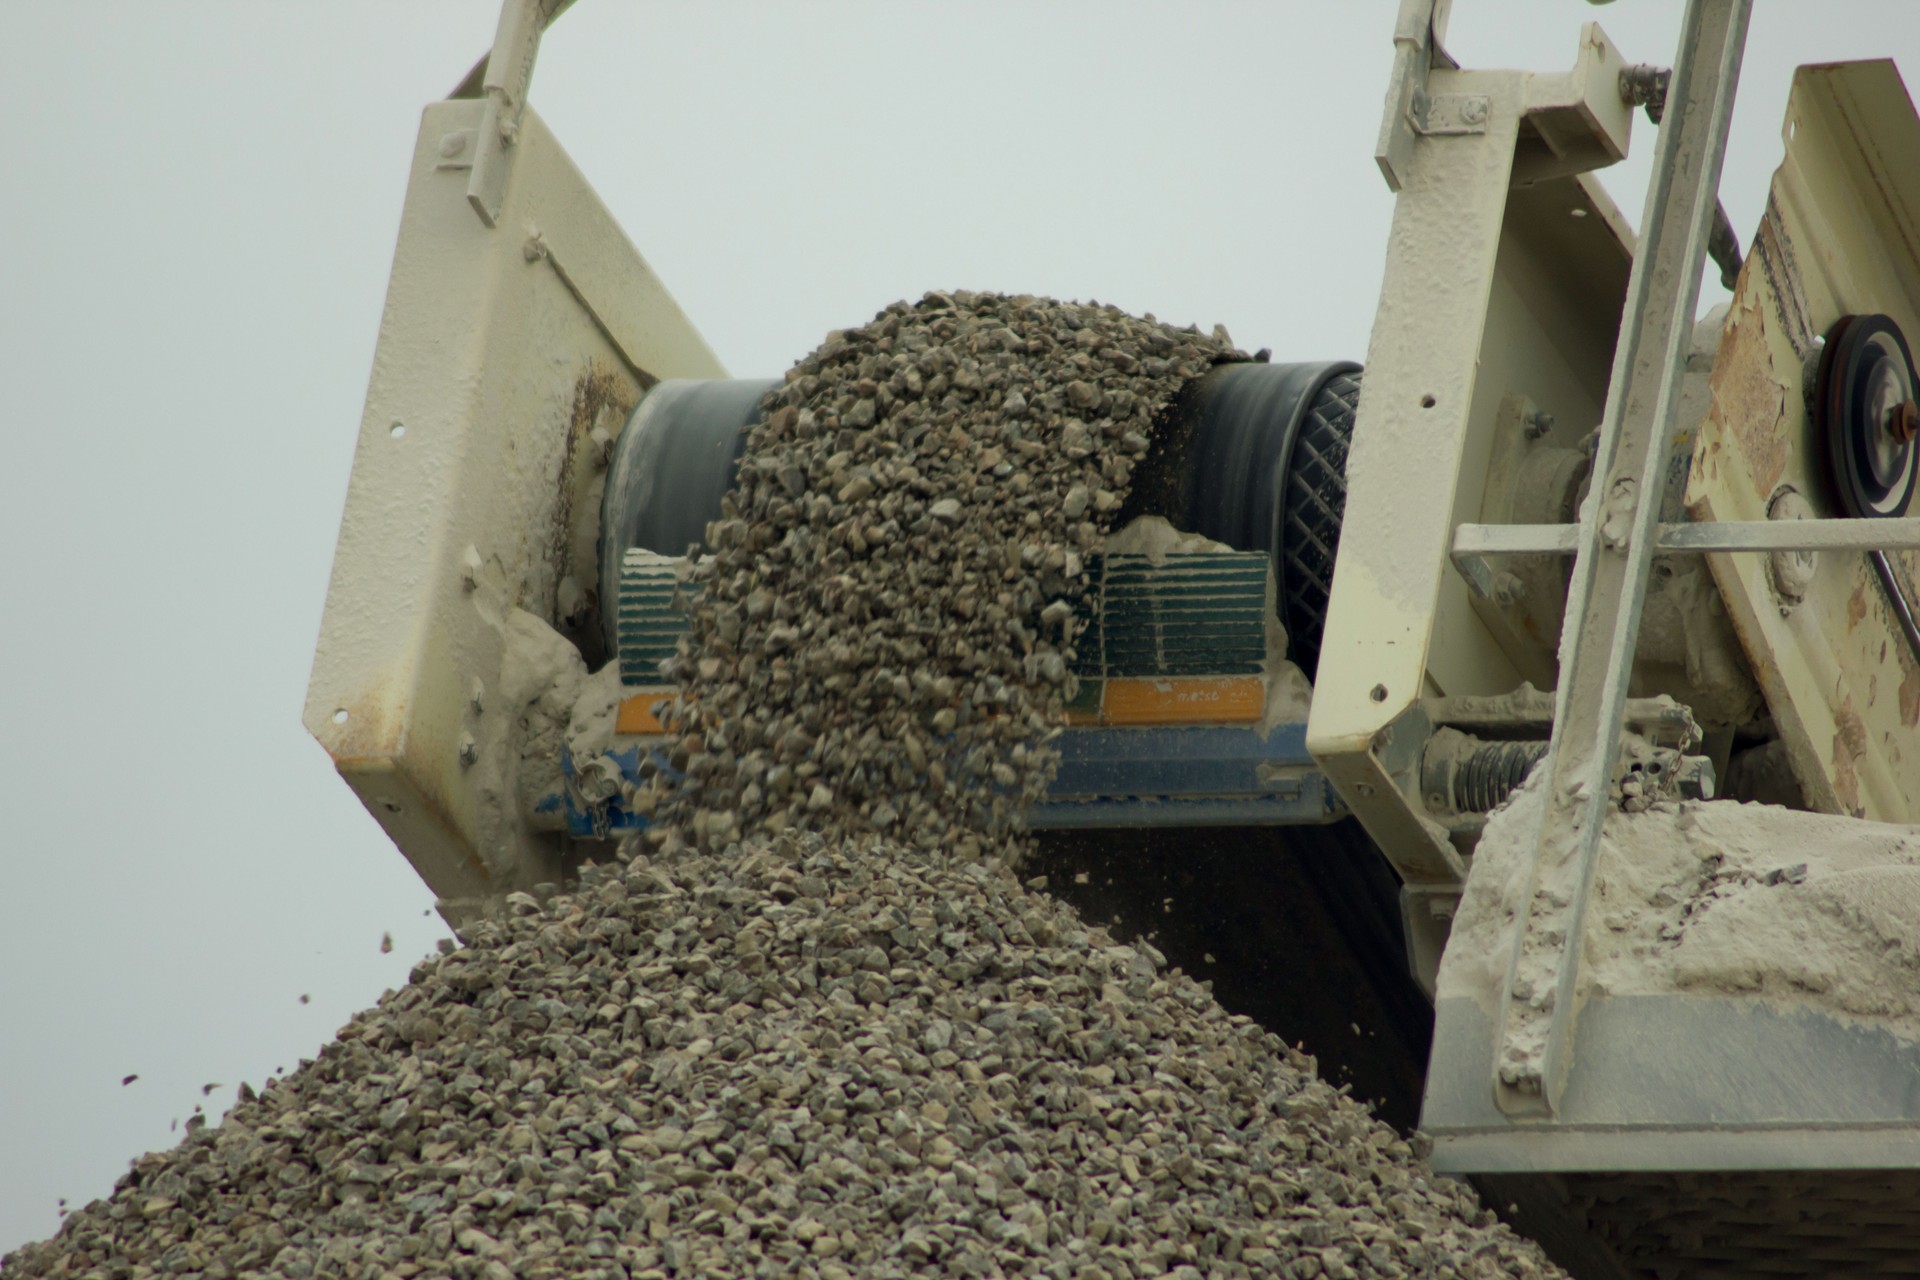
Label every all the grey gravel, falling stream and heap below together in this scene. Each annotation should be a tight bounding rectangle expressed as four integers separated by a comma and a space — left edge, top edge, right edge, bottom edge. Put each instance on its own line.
4, 294, 1555, 1280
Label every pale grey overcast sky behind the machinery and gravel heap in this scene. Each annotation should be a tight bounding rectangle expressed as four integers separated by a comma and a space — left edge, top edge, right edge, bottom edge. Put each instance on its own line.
0, 0, 1920, 1251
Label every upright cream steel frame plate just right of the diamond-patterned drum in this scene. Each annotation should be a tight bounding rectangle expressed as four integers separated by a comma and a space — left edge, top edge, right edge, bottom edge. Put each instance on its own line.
1308, 23, 1632, 889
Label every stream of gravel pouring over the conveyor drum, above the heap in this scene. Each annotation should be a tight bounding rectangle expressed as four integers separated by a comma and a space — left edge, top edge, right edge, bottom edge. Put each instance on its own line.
659, 294, 1246, 856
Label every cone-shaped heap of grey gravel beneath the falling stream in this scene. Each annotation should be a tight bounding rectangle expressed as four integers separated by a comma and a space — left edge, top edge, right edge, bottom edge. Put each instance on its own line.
8, 833, 1542, 1280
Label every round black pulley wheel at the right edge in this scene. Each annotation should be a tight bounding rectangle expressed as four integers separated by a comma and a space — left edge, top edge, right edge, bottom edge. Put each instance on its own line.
1814, 315, 1920, 516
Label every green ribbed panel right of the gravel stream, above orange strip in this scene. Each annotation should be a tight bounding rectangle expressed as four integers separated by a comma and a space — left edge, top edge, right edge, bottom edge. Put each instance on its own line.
1073, 551, 1269, 679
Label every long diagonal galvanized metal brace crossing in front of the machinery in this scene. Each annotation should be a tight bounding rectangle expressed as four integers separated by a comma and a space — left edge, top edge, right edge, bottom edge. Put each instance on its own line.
1492, 0, 1751, 1115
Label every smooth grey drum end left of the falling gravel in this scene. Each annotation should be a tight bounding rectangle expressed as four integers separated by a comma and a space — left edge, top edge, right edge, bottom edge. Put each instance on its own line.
599, 378, 780, 652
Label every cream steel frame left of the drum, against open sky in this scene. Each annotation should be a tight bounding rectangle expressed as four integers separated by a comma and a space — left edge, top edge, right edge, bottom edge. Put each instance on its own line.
305, 100, 726, 910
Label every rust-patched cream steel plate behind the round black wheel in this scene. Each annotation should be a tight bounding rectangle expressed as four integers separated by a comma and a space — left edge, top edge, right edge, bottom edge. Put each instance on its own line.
1688, 61, 1920, 821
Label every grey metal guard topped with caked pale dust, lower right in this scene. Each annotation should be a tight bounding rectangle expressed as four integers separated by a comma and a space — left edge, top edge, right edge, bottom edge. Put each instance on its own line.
1421, 752, 1920, 1276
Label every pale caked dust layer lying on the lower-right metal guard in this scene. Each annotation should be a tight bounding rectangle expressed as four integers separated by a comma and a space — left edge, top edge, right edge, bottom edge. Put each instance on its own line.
1440, 783, 1920, 1042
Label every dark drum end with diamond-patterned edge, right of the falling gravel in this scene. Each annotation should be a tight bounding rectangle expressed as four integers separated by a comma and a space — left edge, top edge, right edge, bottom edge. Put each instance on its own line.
1160, 361, 1361, 679
